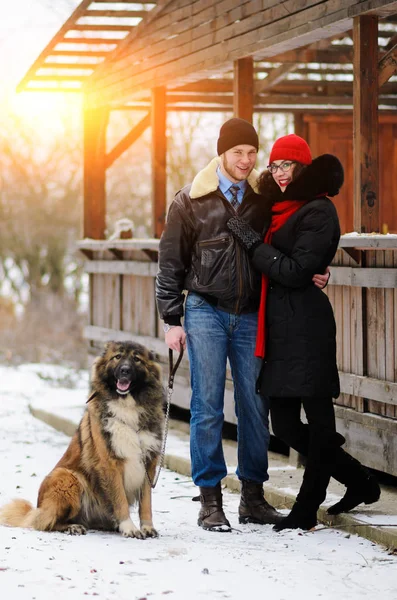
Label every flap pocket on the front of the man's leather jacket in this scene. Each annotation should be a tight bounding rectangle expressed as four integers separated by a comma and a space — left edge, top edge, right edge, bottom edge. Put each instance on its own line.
193, 235, 234, 293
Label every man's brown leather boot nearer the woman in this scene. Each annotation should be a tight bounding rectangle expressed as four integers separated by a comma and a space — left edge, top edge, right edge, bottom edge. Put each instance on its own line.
238, 480, 282, 525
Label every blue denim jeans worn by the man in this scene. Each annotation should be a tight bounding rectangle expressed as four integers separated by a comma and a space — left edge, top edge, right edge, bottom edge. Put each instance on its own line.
184, 293, 270, 487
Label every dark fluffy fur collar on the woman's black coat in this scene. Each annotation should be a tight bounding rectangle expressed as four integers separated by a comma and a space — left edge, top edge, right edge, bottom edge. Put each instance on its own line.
259, 154, 344, 203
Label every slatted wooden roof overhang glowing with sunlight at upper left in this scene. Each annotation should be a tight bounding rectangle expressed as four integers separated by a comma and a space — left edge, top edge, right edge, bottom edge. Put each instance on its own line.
19, 0, 397, 111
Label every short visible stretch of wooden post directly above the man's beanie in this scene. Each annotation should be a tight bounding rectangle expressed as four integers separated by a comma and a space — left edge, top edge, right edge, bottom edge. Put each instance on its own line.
233, 56, 254, 123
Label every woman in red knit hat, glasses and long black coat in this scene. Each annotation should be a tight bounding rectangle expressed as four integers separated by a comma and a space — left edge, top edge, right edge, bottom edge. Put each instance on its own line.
228, 134, 380, 531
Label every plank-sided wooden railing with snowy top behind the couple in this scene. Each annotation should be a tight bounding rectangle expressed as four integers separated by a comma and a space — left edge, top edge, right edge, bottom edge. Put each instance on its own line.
78, 235, 397, 475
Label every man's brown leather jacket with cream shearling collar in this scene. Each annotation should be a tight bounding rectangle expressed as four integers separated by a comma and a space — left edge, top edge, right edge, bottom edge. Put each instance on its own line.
156, 158, 270, 324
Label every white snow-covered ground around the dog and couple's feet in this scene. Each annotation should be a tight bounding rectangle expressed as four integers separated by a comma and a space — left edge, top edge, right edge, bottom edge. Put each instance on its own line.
0, 365, 397, 600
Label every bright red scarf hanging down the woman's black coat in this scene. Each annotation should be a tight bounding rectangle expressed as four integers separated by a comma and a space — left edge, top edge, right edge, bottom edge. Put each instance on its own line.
255, 200, 306, 358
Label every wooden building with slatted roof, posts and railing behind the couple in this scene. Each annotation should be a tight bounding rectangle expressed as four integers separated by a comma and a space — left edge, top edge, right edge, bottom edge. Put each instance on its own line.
19, 0, 397, 475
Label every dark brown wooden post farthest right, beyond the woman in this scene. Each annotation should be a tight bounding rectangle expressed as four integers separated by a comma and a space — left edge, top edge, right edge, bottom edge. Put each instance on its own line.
353, 16, 379, 233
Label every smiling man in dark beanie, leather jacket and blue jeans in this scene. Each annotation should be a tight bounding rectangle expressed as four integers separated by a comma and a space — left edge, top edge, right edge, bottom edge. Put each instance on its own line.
156, 118, 326, 531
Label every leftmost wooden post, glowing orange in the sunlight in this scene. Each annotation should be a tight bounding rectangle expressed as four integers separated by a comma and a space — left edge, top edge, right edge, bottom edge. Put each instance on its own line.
83, 99, 109, 240
